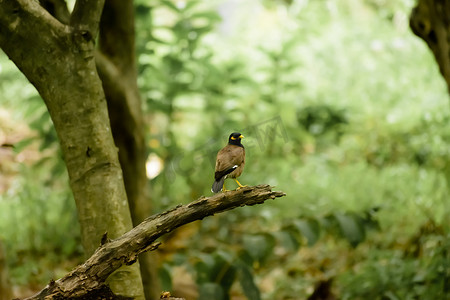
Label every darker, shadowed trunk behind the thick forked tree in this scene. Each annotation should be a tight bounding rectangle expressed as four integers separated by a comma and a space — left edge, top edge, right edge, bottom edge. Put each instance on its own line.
96, 0, 160, 299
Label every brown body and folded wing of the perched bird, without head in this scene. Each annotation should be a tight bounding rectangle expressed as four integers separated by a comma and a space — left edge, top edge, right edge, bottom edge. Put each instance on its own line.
215, 145, 245, 180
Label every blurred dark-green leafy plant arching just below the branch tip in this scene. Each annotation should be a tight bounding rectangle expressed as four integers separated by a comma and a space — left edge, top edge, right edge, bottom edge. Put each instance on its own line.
163, 210, 378, 300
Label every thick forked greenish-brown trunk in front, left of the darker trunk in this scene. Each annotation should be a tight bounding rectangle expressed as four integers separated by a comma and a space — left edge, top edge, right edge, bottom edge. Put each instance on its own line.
0, 0, 143, 299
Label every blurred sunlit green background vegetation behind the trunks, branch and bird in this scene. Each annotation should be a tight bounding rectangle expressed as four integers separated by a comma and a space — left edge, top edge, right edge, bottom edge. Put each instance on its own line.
0, 0, 450, 299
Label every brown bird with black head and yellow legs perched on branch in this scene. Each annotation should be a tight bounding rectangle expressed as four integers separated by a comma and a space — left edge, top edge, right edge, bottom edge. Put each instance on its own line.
211, 132, 245, 193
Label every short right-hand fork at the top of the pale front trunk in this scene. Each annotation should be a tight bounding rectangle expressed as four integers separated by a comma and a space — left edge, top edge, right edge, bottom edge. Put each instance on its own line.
70, 0, 105, 38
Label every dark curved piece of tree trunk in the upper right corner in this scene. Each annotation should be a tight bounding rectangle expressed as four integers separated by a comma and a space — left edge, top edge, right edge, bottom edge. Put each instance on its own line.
409, 0, 450, 91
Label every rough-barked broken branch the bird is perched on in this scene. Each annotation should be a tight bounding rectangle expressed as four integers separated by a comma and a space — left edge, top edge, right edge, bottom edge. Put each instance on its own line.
26, 185, 286, 300
